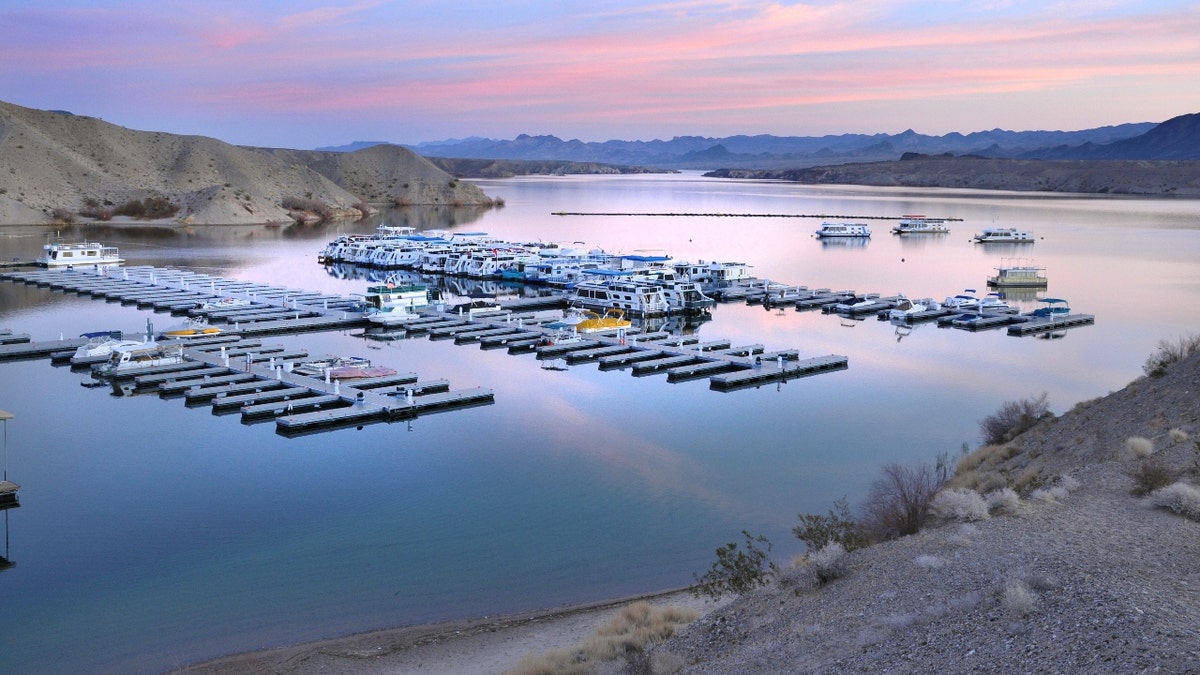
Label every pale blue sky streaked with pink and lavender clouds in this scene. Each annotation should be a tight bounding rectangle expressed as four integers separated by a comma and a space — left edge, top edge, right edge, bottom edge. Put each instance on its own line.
0, 0, 1200, 148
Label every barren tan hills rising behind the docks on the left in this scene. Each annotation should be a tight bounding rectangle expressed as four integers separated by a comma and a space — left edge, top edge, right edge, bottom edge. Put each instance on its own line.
0, 102, 491, 225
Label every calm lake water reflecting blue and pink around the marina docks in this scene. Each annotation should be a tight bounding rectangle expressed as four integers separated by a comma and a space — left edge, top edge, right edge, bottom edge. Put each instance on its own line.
0, 174, 1200, 673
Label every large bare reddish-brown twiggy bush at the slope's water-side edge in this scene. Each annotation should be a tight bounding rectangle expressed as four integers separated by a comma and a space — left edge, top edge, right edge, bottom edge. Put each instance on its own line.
863, 464, 942, 540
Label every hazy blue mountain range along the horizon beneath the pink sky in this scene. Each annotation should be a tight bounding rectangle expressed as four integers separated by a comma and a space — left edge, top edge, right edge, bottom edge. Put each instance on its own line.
398, 123, 1156, 169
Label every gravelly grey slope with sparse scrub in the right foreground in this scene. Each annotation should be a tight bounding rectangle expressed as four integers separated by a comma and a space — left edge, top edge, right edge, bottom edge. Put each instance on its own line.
652, 343, 1200, 674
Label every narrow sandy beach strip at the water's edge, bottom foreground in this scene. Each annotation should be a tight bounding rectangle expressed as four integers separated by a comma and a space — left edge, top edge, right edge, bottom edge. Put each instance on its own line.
168, 587, 728, 675
